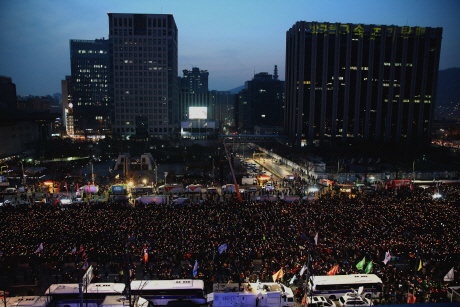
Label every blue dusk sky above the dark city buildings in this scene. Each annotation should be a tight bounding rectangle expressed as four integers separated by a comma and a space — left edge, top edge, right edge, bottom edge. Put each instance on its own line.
0, 0, 460, 95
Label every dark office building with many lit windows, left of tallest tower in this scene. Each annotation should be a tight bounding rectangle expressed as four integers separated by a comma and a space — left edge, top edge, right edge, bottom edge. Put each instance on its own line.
69, 39, 112, 138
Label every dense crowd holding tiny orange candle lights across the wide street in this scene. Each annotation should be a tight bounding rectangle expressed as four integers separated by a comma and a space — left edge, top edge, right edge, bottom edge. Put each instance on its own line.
0, 186, 460, 303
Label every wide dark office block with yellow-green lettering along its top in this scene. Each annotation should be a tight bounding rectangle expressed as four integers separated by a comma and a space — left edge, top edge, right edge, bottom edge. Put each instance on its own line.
284, 21, 442, 146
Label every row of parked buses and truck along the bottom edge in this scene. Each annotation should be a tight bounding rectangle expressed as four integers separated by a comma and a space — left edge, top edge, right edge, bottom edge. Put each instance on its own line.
6, 274, 383, 307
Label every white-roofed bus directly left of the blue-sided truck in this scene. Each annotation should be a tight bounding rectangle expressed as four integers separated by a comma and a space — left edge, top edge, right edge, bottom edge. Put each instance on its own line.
131, 279, 206, 306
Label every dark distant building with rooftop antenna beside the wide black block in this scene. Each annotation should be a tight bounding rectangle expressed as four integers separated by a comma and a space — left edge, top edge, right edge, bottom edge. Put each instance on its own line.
238, 65, 285, 134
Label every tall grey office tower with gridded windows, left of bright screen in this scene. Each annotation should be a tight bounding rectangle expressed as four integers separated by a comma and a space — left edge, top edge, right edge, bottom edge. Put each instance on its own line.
108, 13, 179, 139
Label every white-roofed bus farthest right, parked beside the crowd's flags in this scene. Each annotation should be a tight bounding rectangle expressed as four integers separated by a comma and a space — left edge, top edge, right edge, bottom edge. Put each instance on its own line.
310, 274, 383, 300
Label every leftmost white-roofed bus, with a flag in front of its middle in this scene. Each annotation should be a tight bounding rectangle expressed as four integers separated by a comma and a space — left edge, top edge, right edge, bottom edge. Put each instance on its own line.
45, 282, 125, 307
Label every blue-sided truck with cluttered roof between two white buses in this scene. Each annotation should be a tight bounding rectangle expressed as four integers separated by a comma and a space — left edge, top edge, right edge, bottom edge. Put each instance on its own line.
207, 282, 295, 307
